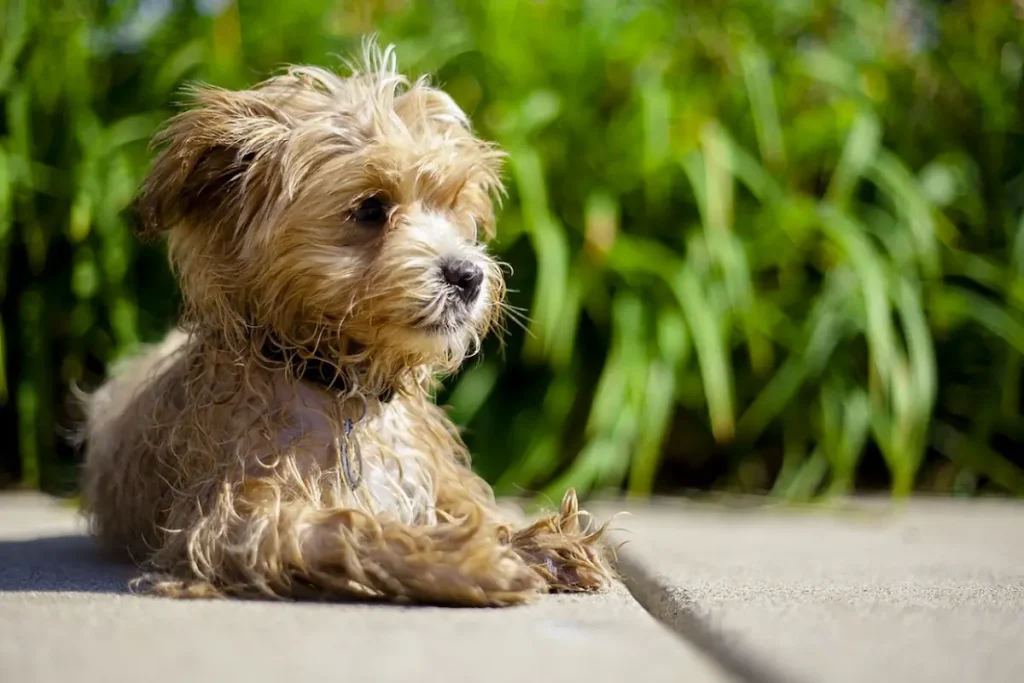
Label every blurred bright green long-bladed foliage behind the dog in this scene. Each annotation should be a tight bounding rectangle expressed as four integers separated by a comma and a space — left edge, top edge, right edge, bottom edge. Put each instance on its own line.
0, 0, 1024, 499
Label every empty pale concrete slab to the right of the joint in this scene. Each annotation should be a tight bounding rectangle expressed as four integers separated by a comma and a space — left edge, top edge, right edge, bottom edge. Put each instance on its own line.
589, 500, 1024, 683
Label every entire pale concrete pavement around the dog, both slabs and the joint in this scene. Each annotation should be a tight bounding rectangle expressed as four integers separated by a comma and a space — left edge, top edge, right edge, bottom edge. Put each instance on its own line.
0, 495, 1024, 683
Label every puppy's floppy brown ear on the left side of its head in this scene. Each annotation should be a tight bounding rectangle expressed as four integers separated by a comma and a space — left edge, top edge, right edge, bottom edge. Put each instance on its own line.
135, 86, 290, 238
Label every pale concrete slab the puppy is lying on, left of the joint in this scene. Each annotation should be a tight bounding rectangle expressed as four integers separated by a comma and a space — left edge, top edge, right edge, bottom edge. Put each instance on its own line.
0, 495, 727, 683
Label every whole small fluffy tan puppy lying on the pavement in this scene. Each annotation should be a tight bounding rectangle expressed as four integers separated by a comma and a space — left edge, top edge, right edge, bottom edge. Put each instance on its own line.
81, 42, 612, 605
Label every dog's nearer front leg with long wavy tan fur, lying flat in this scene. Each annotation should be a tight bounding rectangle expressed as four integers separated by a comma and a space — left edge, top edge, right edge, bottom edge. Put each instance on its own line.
142, 486, 545, 606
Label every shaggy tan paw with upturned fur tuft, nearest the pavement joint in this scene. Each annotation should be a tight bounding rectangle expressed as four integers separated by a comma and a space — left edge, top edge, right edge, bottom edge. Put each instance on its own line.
511, 489, 615, 593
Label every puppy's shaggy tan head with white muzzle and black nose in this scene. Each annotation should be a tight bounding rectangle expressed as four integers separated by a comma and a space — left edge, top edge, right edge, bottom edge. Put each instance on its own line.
138, 43, 504, 376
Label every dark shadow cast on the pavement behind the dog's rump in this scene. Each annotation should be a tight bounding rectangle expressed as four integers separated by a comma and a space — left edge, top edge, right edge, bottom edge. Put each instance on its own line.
0, 535, 136, 593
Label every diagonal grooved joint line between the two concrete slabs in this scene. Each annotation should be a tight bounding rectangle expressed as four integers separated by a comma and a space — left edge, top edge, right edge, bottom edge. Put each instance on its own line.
612, 532, 807, 683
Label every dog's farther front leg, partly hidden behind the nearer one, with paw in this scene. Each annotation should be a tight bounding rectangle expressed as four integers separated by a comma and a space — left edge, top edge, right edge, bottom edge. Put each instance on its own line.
437, 467, 614, 592
